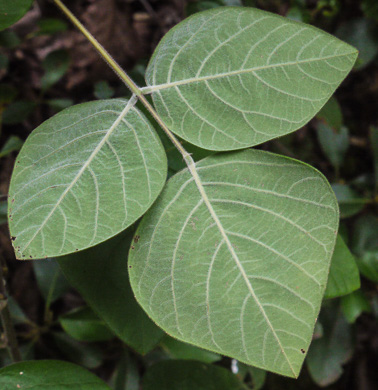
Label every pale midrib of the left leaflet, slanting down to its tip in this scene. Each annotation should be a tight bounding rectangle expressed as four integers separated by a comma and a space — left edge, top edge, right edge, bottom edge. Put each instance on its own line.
20, 97, 136, 253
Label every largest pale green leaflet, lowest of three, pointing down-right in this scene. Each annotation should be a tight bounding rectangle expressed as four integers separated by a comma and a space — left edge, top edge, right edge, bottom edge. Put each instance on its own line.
129, 150, 339, 377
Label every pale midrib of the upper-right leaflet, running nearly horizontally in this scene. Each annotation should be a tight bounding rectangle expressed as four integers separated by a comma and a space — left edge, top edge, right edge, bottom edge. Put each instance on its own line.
141, 52, 355, 94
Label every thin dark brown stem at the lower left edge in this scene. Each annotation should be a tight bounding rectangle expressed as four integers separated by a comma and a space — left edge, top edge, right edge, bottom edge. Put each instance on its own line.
0, 257, 22, 363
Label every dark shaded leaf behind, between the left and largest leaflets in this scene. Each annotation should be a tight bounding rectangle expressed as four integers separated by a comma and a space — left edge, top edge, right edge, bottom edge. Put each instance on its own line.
59, 233, 163, 354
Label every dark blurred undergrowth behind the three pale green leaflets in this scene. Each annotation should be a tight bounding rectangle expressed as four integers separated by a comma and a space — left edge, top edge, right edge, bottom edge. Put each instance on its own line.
0, 0, 378, 390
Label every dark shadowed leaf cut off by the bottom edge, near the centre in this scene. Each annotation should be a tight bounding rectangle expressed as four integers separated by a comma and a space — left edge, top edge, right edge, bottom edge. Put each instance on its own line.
143, 360, 247, 390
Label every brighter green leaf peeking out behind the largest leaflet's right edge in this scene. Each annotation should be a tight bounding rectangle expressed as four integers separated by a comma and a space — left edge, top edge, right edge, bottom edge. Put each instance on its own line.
324, 235, 360, 298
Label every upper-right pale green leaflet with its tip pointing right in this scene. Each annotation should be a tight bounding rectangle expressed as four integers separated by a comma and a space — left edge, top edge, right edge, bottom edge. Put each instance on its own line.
145, 7, 357, 150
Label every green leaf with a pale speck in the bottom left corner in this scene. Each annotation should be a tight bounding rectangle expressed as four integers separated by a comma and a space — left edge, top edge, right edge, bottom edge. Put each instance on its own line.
0, 360, 110, 390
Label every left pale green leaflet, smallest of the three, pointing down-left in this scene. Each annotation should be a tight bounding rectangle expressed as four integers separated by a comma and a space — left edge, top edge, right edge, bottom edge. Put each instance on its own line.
9, 99, 167, 259
